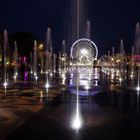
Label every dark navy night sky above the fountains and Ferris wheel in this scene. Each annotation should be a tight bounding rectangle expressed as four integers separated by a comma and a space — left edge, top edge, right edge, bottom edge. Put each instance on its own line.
0, 0, 140, 54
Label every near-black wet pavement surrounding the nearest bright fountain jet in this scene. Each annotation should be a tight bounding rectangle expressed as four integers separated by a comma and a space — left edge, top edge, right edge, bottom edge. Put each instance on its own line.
4, 93, 140, 140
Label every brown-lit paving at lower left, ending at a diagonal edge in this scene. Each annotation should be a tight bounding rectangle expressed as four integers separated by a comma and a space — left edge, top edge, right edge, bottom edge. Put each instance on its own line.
0, 83, 63, 140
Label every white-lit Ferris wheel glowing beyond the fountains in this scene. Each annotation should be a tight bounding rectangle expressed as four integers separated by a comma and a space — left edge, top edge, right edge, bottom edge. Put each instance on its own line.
71, 38, 98, 65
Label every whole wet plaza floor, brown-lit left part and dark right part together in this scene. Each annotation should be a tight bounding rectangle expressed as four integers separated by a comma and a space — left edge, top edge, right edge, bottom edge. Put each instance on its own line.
0, 70, 140, 140
